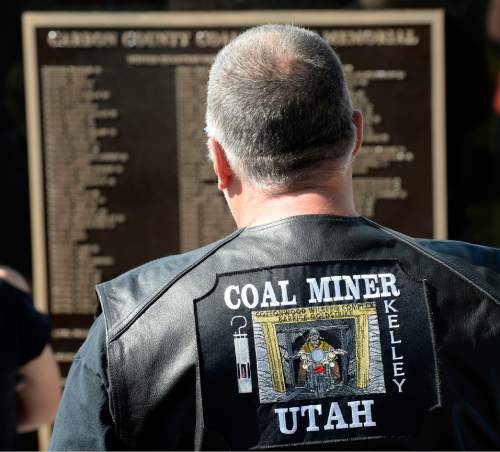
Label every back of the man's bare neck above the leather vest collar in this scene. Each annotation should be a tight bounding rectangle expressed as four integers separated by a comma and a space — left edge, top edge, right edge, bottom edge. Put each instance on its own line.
231, 178, 358, 227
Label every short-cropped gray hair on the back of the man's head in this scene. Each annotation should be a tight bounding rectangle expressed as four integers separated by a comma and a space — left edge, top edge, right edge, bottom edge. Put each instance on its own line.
206, 25, 355, 188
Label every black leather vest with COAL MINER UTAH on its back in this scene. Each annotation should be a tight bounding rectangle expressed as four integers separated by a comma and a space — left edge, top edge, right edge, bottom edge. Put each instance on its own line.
97, 215, 500, 450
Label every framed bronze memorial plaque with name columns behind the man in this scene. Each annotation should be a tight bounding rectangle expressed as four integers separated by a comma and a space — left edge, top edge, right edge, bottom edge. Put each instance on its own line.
23, 10, 446, 374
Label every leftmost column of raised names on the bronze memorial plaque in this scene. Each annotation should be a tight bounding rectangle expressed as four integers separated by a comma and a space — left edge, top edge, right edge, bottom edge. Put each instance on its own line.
41, 66, 127, 314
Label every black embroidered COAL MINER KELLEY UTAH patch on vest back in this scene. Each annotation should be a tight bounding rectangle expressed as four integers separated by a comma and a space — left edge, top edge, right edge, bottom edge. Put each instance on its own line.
195, 261, 439, 449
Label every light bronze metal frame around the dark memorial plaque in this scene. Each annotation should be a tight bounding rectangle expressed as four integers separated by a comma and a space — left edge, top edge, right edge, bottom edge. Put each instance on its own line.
22, 10, 448, 318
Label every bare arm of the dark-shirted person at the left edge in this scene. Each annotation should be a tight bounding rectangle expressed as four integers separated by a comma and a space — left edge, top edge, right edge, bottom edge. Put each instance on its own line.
16, 345, 61, 432
